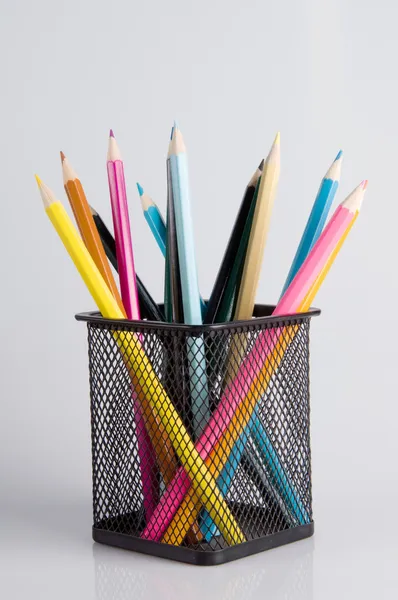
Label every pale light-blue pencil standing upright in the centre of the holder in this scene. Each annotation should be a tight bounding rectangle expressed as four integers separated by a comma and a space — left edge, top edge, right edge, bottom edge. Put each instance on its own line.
168, 125, 210, 438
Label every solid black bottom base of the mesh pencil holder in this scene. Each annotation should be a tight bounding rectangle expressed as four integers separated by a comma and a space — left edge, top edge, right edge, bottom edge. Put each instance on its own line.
93, 513, 314, 567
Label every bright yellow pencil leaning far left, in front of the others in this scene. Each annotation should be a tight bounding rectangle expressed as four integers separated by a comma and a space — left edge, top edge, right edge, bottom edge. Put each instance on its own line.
36, 177, 246, 545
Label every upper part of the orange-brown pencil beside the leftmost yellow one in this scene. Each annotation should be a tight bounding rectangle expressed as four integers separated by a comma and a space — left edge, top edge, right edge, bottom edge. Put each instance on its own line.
60, 152, 125, 312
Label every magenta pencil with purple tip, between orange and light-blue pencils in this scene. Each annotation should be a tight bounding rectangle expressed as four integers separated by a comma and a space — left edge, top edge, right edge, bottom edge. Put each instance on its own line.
107, 129, 157, 519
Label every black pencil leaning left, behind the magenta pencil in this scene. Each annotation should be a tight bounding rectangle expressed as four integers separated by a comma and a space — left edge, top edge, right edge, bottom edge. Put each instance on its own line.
90, 206, 164, 321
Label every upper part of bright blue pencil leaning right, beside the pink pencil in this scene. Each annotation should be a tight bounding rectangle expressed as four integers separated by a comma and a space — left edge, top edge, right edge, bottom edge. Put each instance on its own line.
281, 150, 343, 298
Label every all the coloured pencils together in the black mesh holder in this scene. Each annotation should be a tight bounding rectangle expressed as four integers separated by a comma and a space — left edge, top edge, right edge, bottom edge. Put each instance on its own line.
37, 124, 367, 545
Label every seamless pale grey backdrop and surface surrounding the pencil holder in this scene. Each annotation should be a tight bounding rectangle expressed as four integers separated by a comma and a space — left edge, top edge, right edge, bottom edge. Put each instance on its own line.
0, 0, 398, 600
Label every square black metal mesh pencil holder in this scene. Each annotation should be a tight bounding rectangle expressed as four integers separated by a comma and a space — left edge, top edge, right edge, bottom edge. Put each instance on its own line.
76, 305, 319, 565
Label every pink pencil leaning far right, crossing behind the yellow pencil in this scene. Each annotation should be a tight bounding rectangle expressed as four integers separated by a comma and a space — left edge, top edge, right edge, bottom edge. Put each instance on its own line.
141, 181, 367, 541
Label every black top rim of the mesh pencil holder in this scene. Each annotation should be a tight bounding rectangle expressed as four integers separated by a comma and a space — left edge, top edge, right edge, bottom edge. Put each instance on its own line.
75, 304, 321, 334
